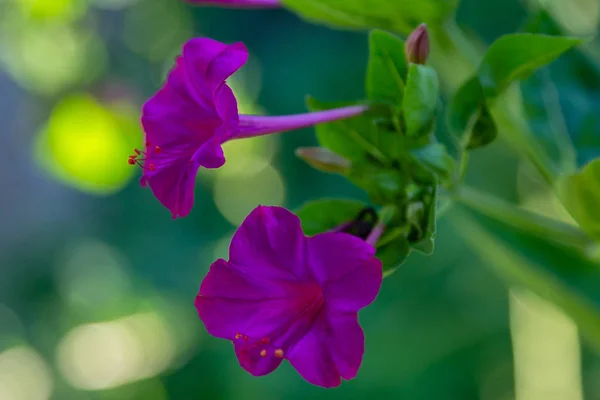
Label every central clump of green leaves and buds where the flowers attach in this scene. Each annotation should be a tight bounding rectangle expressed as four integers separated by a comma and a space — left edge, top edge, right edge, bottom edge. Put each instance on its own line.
305, 30, 455, 273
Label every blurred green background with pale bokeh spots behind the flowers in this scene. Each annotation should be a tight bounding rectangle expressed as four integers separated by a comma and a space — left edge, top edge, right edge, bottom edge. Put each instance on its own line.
0, 0, 600, 400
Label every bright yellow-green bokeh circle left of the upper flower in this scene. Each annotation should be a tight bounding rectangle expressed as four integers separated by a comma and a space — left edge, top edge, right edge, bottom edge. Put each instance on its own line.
36, 95, 141, 194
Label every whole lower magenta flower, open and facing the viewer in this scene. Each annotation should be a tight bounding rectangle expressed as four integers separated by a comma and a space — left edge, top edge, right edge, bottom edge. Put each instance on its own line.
195, 206, 382, 387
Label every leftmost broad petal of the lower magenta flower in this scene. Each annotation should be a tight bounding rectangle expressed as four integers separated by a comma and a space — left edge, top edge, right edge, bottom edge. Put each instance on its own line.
195, 259, 310, 340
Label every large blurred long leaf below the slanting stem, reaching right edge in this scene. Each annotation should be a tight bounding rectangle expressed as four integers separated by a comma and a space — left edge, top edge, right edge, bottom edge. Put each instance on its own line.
449, 210, 600, 351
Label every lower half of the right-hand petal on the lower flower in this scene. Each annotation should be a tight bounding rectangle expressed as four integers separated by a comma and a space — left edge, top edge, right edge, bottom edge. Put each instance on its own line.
323, 257, 383, 312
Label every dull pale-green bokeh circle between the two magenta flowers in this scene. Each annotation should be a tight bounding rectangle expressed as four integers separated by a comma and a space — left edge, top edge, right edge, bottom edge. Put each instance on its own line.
213, 161, 285, 225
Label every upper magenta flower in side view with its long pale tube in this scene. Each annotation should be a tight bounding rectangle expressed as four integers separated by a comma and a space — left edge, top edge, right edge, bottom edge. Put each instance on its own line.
129, 38, 366, 218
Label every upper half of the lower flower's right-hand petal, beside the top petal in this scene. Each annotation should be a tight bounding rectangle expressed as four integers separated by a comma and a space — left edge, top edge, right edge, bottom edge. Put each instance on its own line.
308, 232, 375, 286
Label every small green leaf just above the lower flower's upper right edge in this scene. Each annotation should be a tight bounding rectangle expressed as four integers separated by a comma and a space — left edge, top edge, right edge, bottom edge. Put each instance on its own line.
296, 199, 368, 236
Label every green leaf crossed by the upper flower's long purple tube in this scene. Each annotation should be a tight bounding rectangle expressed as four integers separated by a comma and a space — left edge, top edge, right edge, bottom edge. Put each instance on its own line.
306, 97, 386, 161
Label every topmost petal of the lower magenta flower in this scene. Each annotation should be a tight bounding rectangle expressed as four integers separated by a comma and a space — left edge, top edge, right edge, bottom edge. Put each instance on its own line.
229, 206, 311, 282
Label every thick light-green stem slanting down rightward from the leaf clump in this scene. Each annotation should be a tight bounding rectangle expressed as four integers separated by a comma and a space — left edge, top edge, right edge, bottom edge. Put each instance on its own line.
451, 186, 594, 251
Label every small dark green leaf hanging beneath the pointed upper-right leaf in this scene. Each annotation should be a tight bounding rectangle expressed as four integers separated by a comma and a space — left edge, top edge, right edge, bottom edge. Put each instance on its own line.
446, 76, 498, 151
